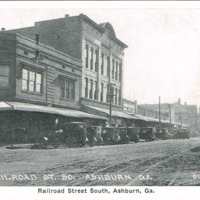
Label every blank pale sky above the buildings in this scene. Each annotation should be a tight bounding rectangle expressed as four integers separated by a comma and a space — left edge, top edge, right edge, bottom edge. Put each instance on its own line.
0, 3, 200, 106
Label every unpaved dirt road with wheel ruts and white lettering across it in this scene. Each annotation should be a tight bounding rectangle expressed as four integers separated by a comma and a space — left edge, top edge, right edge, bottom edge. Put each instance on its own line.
0, 138, 200, 186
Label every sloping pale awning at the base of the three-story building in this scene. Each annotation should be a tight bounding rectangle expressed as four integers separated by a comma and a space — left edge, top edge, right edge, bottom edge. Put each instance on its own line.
84, 105, 136, 119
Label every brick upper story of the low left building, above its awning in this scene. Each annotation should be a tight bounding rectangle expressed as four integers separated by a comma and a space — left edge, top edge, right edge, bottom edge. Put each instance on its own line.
0, 32, 81, 109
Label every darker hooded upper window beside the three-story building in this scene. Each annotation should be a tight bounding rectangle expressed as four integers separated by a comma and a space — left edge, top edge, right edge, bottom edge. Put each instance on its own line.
60, 79, 75, 100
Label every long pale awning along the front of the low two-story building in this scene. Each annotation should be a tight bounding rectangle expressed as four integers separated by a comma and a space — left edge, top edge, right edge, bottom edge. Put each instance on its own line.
0, 102, 107, 120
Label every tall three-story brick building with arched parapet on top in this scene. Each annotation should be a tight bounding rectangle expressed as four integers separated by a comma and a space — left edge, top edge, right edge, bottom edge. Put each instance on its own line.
9, 14, 130, 125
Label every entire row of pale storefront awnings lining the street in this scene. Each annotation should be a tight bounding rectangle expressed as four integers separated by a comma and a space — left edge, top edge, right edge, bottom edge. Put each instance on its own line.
0, 102, 187, 126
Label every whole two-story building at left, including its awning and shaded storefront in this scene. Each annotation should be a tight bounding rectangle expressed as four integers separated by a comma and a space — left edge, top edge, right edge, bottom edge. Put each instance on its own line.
0, 31, 105, 141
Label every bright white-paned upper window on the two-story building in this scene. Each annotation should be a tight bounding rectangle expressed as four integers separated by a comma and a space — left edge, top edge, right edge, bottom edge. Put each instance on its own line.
22, 69, 42, 93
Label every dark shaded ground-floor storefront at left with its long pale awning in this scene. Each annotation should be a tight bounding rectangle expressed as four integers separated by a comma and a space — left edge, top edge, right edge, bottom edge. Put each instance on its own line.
0, 102, 107, 143
